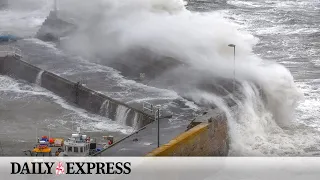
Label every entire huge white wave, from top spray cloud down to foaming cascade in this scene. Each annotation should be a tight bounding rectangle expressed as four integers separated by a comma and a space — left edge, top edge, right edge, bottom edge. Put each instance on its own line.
0, 0, 316, 155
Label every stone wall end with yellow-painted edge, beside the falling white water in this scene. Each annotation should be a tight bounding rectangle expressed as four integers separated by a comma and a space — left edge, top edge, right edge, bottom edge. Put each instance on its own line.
147, 110, 229, 156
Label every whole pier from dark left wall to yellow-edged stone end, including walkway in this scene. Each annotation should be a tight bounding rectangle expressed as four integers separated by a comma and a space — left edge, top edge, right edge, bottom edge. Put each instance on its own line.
0, 45, 228, 156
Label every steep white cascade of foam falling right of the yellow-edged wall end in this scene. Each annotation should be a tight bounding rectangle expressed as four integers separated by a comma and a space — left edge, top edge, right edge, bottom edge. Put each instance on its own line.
229, 82, 300, 156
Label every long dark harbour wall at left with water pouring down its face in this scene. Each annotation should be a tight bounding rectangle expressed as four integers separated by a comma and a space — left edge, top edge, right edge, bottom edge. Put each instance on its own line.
0, 56, 154, 129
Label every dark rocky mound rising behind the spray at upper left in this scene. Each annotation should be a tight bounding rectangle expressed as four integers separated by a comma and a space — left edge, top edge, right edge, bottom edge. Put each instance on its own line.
36, 11, 76, 41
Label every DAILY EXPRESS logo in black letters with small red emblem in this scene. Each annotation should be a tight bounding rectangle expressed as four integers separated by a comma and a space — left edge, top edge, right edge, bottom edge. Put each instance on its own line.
11, 162, 131, 175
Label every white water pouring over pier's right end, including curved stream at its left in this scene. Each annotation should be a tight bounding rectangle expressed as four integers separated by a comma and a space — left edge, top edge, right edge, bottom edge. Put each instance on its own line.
185, 81, 300, 156
